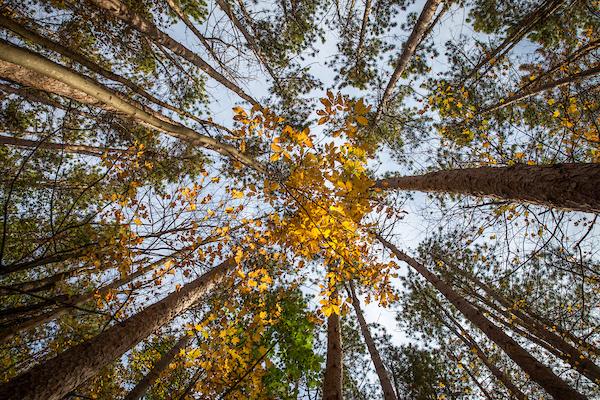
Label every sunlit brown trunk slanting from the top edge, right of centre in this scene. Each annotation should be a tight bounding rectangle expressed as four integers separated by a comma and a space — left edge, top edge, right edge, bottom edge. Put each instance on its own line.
375, 0, 442, 121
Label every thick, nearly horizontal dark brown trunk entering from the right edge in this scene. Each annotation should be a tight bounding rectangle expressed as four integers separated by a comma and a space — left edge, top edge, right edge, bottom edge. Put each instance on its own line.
375, 163, 600, 212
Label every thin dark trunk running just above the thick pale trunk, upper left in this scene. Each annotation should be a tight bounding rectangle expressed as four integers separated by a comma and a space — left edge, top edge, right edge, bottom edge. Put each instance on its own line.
0, 15, 229, 131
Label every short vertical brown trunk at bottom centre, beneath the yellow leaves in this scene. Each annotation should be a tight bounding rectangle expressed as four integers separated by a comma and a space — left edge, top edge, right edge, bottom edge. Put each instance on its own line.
323, 313, 343, 400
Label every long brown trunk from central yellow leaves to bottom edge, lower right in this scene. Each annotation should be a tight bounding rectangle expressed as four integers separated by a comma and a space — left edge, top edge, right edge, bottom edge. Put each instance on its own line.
377, 235, 586, 400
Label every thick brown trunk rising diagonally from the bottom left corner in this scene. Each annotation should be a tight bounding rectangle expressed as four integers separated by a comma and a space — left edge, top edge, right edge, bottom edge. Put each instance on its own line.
0, 259, 235, 400
